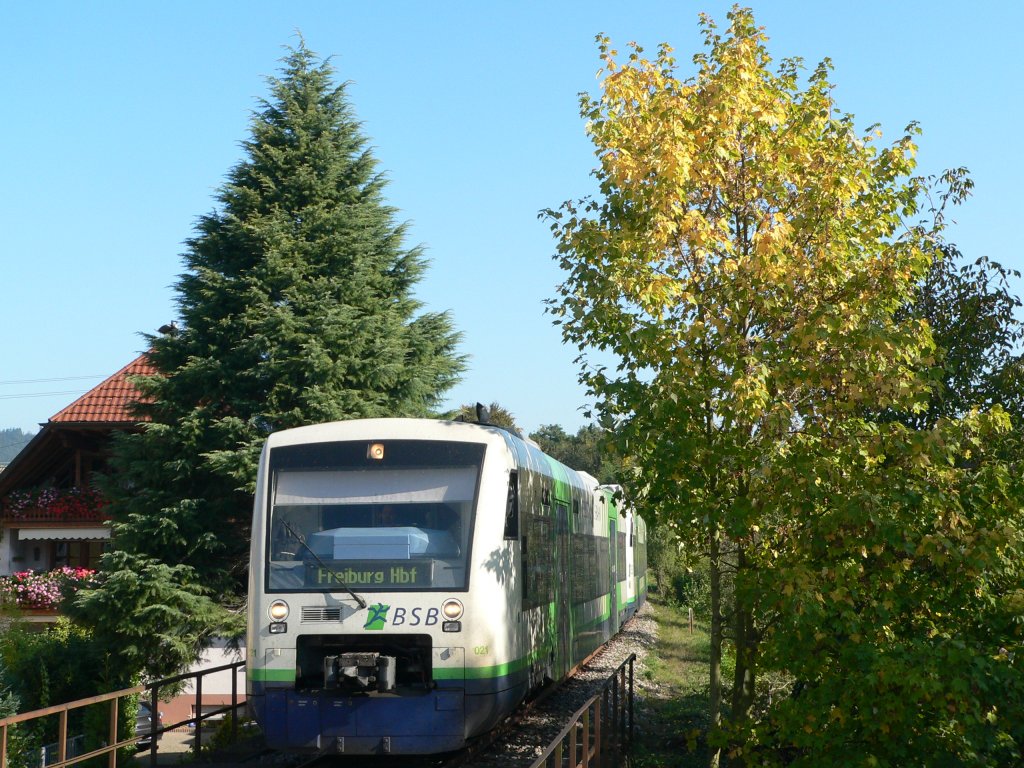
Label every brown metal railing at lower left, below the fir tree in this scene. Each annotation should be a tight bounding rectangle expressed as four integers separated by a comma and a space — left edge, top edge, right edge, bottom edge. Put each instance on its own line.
0, 662, 246, 768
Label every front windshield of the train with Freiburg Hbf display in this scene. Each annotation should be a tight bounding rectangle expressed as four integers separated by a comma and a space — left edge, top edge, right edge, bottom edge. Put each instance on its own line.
266, 440, 484, 592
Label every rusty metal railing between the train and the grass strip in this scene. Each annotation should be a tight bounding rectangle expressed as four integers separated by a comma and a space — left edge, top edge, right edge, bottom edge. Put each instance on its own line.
530, 653, 637, 768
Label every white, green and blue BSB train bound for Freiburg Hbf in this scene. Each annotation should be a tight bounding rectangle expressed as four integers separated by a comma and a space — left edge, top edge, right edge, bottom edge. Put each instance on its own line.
246, 419, 647, 755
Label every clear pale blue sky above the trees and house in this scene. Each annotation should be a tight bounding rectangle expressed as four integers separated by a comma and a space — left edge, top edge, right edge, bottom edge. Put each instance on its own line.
0, 0, 1024, 438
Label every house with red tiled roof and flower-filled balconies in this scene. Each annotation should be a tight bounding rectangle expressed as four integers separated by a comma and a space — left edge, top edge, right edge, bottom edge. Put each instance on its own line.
0, 354, 155, 622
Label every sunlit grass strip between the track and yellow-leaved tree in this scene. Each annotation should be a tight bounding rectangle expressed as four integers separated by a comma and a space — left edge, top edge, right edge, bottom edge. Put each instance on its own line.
630, 596, 711, 768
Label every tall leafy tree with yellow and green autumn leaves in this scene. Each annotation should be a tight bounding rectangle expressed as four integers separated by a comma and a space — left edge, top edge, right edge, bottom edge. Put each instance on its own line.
546, 8, 1020, 765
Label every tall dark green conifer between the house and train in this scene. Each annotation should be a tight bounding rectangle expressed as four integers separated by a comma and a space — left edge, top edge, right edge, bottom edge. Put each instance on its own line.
77, 42, 464, 672
